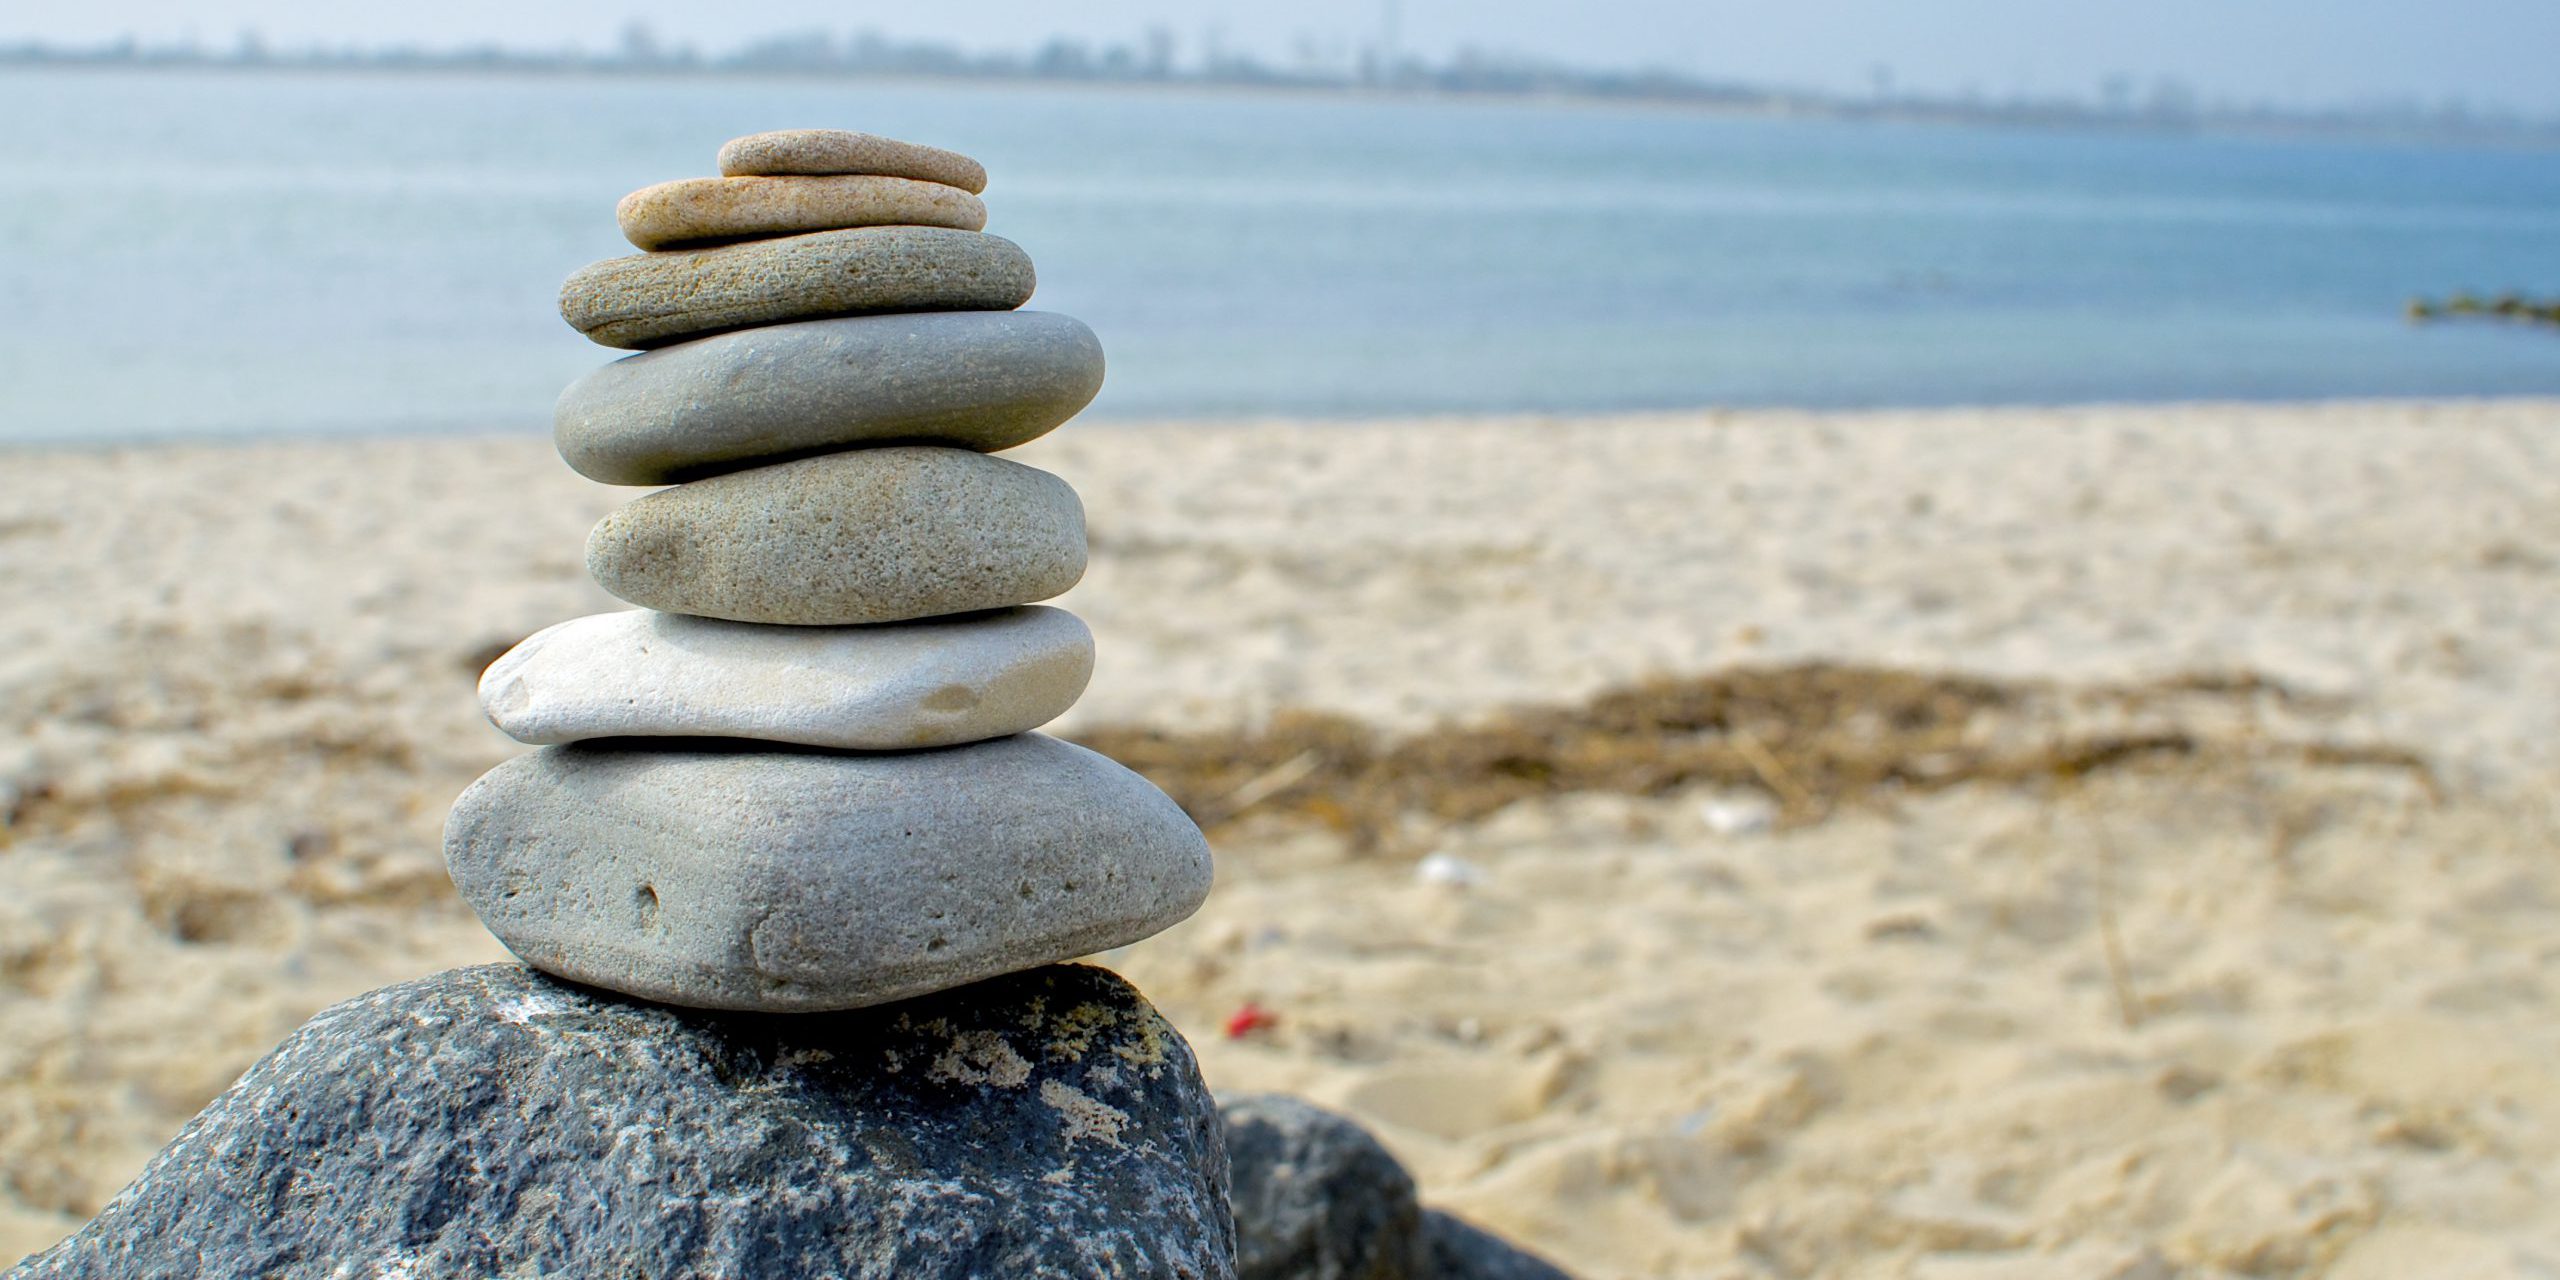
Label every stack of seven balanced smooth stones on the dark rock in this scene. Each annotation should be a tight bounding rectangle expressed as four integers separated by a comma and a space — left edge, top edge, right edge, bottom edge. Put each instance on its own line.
445, 131, 1208, 1011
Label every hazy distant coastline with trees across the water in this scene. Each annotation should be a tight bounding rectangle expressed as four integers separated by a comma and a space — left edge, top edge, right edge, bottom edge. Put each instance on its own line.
0, 26, 2560, 148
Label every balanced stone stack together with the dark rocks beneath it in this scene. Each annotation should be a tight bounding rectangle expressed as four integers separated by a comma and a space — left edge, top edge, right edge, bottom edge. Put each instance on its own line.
8, 131, 1564, 1280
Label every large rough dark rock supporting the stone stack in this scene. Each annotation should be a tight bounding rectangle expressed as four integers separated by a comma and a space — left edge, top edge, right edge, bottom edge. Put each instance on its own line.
10, 965, 1234, 1280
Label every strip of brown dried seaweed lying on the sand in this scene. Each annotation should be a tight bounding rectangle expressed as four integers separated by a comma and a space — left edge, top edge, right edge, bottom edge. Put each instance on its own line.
1073, 663, 2435, 852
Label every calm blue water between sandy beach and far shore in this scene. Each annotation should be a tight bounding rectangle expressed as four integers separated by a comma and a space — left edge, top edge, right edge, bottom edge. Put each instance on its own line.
0, 69, 2560, 440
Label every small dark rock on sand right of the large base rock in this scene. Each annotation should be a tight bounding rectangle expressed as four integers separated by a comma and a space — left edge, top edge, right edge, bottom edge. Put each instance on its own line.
1219, 1093, 1569, 1280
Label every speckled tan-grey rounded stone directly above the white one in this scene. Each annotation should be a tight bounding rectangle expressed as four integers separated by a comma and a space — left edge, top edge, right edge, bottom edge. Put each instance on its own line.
586, 445, 1085, 627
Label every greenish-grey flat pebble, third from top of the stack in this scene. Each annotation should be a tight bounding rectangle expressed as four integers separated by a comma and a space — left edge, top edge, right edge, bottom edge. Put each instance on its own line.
561, 228, 1034, 348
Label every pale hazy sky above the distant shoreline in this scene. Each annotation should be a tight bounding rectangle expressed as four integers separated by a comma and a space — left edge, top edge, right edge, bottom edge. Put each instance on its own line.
20, 0, 2560, 113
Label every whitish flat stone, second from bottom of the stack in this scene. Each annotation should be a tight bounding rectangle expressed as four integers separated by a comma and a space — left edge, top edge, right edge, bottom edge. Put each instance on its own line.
479, 604, 1093, 750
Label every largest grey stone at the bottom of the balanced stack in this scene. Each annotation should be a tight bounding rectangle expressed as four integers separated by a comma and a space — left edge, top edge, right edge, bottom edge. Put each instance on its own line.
445, 735, 1208, 1011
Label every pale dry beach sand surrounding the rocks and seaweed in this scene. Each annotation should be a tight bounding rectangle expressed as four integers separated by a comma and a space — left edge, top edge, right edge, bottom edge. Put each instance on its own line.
0, 402, 2560, 1280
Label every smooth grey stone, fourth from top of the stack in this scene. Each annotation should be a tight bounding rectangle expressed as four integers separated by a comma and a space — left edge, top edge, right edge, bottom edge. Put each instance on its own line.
553, 312, 1103, 484
